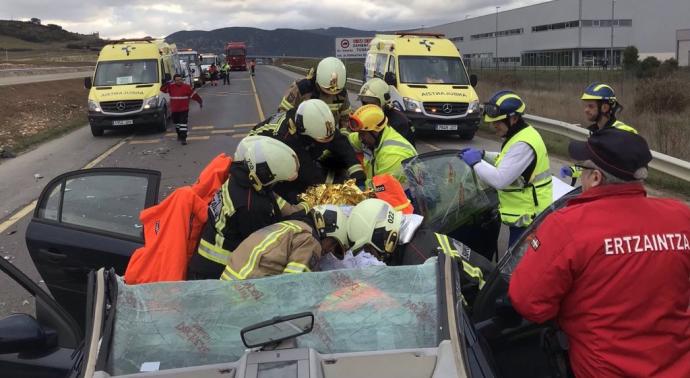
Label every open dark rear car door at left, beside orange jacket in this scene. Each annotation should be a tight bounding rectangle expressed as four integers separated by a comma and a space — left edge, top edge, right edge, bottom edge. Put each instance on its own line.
26, 168, 160, 324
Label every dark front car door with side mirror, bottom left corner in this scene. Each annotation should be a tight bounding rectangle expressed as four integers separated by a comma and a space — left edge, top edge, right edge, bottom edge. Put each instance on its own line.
0, 250, 82, 378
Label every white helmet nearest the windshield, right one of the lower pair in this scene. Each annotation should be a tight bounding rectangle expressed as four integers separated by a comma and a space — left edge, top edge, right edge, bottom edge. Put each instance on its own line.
347, 198, 402, 253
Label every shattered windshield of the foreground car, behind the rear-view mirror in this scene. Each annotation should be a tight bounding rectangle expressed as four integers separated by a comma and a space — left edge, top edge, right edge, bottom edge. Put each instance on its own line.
110, 258, 440, 374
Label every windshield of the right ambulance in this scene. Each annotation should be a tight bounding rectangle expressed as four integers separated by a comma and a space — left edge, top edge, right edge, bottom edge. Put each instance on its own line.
398, 56, 469, 85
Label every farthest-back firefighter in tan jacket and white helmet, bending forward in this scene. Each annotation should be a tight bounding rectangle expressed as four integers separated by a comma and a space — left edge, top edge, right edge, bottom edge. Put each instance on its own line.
278, 57, 351, 131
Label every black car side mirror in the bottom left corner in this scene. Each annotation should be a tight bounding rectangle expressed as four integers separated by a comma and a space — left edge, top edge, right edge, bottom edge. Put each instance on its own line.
0, 314, 57, 354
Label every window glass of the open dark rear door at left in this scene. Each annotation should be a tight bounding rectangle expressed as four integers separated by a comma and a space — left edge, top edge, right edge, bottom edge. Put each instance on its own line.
37, 169, 160, 238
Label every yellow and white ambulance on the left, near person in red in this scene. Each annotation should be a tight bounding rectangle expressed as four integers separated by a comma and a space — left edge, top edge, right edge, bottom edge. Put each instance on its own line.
84, 38, 181, 136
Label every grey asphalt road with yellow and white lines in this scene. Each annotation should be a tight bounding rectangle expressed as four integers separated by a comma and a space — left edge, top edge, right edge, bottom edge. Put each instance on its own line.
0, 66, 562, 318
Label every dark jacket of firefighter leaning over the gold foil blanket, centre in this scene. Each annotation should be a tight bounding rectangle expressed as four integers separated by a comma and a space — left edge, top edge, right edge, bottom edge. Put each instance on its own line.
249, 110, 365, 202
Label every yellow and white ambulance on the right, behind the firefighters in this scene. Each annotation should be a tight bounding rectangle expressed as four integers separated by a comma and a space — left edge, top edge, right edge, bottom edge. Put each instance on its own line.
364, 32, 481, 139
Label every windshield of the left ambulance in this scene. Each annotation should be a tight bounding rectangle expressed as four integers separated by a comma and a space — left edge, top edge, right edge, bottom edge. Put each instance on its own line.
94, 59, 158, 87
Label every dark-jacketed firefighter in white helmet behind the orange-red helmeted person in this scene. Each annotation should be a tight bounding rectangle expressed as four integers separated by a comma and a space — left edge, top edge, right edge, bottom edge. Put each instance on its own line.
357, 78, 414, 146
